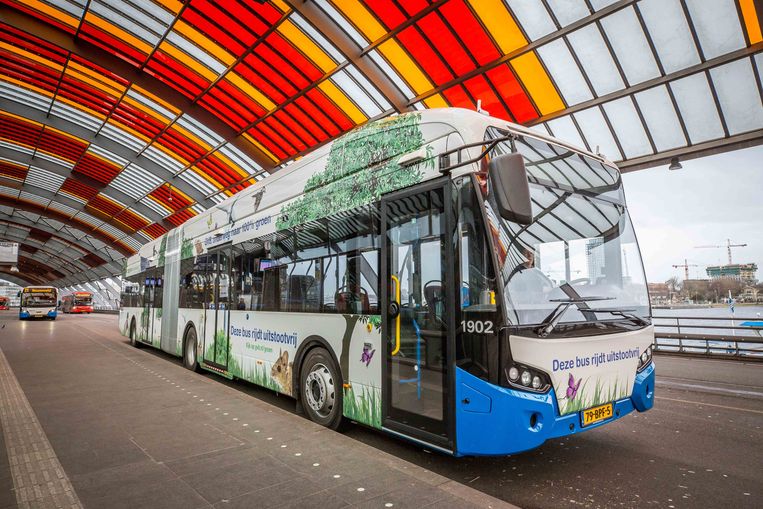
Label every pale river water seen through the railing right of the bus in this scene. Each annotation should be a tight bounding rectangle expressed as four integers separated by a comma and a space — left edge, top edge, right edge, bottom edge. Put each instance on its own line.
652, 305, 763, 356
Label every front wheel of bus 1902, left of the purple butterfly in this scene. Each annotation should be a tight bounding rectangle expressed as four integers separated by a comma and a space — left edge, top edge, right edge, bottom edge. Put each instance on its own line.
299, 348, 342, 430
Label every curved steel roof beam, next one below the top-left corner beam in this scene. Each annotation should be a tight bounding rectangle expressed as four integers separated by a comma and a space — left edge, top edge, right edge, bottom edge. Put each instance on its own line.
0, 101, 214, 208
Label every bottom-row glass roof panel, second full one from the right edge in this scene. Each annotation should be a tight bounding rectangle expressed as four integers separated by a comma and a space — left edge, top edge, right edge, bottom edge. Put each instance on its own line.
669, 73, 723, 143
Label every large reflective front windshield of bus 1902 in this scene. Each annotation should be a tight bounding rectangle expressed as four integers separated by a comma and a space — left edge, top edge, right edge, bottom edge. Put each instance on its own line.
488, 133, 650, 325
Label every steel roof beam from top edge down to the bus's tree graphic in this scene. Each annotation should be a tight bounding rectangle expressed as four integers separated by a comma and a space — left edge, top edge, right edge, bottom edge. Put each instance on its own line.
286, 0, 412, 113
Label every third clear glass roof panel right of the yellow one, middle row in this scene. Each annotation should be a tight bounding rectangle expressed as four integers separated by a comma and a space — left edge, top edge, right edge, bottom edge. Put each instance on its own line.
601, 7, 660, 85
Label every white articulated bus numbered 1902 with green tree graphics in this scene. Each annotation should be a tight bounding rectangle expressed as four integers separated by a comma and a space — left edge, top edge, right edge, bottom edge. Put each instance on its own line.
119, 109, 654, 456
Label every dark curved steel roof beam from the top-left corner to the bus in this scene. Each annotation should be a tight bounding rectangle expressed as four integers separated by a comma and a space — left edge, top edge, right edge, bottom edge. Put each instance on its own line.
0, 8, 274, 172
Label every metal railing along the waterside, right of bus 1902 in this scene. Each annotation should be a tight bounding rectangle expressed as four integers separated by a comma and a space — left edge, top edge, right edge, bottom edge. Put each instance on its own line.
652, 315, 763, 361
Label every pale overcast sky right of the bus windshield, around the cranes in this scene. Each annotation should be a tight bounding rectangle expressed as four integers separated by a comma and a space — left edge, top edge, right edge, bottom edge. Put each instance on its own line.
623, 146, 763, 282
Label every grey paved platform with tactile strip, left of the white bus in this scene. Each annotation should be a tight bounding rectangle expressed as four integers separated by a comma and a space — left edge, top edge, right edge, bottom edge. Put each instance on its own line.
0, 312, 513, 509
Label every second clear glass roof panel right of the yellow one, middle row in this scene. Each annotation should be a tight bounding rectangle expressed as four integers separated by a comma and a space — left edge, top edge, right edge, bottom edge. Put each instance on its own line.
568, 24, 625, 96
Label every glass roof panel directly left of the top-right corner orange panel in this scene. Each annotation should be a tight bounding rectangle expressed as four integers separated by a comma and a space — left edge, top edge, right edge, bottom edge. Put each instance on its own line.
686, 0, 745, 59
